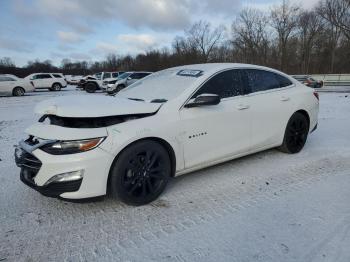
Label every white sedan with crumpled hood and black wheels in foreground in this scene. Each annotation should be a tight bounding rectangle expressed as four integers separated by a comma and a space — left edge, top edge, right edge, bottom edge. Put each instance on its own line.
15, 64, 319, 205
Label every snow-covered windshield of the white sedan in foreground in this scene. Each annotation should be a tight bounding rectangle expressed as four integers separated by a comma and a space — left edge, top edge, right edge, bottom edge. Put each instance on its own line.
117, 68, 198, 101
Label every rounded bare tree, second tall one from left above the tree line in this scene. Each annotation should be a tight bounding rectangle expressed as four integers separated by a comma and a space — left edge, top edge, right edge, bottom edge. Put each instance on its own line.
232, 8, 269, 65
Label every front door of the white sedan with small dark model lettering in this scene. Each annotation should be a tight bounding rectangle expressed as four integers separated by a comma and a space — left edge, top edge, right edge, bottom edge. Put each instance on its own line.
180, 70, 251, 168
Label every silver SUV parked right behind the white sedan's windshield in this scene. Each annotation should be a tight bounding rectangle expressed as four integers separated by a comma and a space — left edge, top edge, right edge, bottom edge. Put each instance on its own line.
105, 72, 152, 95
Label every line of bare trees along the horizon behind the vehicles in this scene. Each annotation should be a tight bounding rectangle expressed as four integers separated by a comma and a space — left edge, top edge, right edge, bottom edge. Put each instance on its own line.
0, 0, 350, 76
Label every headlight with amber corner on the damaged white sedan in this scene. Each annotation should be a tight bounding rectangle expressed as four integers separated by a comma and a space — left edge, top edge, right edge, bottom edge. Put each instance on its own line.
40, 137, 105, 155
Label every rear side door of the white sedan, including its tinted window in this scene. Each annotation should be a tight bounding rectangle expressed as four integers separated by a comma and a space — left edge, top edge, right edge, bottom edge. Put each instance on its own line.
245, 69, 295, 150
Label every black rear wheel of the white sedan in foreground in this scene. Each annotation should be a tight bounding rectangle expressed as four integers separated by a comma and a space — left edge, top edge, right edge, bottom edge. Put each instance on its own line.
279, 112, 310, 154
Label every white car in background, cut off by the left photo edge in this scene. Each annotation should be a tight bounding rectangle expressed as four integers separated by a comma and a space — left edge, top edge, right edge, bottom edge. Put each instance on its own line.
0, 75, 34, 96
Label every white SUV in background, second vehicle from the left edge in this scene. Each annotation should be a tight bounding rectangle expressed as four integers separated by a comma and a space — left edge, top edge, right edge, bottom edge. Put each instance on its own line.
24, 73, 67, 91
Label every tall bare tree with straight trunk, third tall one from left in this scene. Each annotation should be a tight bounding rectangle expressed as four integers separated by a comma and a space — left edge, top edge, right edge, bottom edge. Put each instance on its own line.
270, 0, 300, 70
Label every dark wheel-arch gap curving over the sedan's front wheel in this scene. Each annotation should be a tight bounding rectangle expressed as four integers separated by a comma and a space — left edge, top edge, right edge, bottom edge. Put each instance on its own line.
107, 137, 176, 194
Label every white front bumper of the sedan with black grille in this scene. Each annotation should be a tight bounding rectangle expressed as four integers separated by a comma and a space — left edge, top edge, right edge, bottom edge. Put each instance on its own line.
15, 133, 113, 200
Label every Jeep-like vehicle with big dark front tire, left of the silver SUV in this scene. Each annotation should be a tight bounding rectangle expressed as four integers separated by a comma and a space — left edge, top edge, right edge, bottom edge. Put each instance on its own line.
79, 72, 122, 93
